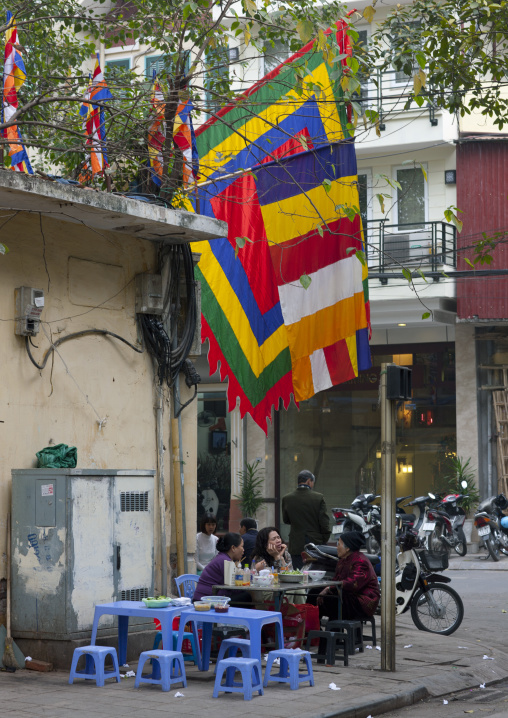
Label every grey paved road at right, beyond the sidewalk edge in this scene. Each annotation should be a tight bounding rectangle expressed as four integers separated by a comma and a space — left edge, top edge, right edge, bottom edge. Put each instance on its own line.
384, 570, 508, 718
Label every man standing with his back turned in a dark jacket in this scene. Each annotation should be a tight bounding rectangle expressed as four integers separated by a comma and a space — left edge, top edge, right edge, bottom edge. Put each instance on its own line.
282, 469, 330, 568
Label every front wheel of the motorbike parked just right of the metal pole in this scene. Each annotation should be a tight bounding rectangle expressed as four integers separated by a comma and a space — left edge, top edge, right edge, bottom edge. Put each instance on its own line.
411, 583, 464, 636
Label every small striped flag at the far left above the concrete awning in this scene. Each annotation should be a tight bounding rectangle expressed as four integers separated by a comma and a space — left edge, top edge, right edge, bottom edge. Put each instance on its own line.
2, 12, 33, 174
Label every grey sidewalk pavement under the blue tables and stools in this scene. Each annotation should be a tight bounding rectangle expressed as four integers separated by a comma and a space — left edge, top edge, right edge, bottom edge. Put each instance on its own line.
0, 615, 508, 718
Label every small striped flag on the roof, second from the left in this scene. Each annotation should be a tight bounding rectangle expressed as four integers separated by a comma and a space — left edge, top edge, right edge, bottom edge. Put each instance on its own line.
79, 55, 113, 179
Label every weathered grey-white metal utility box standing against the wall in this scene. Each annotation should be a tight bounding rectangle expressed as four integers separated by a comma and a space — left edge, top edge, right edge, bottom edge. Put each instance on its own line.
11, 469, 155, 640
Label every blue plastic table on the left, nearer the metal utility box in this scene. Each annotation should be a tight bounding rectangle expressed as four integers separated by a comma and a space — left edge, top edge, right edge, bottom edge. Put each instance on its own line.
90, 601, 185, 673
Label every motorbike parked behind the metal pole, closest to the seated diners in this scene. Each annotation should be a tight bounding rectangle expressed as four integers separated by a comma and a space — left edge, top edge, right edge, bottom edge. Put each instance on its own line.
304, 530, 464, 635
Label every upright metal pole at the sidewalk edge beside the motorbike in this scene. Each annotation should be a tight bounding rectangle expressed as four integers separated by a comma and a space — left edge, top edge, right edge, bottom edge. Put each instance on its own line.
380, 363, 396, 671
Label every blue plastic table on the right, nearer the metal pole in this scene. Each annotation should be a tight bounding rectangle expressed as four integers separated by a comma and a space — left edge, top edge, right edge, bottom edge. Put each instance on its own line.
176, 607, 284, 671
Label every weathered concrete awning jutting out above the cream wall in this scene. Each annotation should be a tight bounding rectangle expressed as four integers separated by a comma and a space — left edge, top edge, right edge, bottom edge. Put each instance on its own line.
0, 170, 227, 244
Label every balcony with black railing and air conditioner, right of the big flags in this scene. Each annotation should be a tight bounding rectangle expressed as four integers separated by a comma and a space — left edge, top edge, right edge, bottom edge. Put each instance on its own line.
364, 219, 457, 284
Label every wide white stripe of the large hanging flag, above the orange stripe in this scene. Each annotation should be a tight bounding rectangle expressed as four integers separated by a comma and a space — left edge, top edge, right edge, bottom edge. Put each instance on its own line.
279, 256, 363, 326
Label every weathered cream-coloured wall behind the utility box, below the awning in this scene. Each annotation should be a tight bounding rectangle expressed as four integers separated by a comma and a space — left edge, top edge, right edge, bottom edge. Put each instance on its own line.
0, 210, 196, 621
